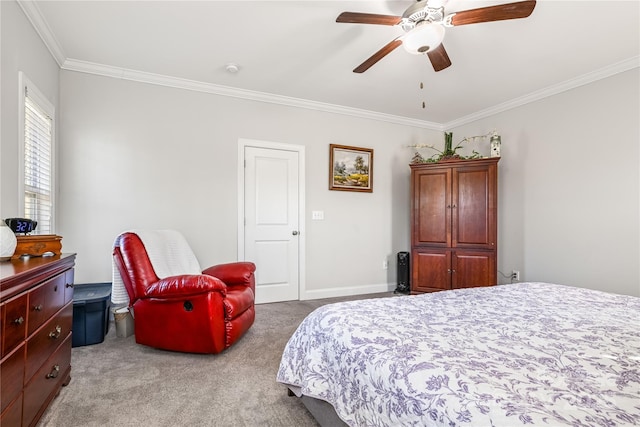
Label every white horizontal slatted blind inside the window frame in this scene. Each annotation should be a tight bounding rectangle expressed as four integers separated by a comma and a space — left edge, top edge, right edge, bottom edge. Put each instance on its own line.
24, 86, 53, 234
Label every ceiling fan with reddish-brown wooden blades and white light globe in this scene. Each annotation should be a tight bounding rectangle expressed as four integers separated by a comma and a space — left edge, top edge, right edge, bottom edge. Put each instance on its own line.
336, 0, 536, 73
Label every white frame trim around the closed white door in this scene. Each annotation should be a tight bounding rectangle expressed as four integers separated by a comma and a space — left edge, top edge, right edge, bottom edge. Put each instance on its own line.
237, 138, 306, 301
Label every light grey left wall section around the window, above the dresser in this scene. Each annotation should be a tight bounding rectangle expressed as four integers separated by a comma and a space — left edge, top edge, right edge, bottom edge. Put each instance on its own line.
0, 1, 60, 218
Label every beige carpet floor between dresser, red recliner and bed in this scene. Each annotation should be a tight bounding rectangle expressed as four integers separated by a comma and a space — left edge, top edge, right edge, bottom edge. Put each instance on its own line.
39, 293, 392, 427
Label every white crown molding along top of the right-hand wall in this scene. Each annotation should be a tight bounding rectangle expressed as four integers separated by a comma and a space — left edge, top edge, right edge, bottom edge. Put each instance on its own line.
443, 56, 640, 129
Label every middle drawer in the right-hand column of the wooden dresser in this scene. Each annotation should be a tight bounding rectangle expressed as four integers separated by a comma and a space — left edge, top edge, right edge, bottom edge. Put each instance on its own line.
24, 303, 73, 382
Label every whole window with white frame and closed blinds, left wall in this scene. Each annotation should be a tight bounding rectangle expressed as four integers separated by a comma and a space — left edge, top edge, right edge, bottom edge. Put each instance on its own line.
20, 73, 55, 234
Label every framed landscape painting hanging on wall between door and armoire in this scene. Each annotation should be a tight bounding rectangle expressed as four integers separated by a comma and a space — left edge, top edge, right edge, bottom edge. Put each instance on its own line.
329, 144, 373, 193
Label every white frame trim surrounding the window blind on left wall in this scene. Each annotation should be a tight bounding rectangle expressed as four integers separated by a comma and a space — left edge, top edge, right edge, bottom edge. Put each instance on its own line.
18, 71, 57, 234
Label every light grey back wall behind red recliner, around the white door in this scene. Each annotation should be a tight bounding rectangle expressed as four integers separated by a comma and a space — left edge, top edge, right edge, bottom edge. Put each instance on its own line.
59, 71, 440, 296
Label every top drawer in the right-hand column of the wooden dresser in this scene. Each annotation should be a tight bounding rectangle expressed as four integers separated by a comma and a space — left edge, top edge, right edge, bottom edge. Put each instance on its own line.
28, 273, 66, 335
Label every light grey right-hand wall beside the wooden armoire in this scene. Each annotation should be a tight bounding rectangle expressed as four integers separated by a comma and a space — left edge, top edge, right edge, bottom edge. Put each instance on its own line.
453, 68, 640, 296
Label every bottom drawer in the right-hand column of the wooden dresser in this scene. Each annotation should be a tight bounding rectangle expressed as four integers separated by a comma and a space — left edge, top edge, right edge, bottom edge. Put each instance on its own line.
22, 335, 71, 426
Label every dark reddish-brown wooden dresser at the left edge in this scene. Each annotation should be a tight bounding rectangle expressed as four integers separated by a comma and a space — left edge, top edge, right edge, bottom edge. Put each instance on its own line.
0, 254, 76, 427
